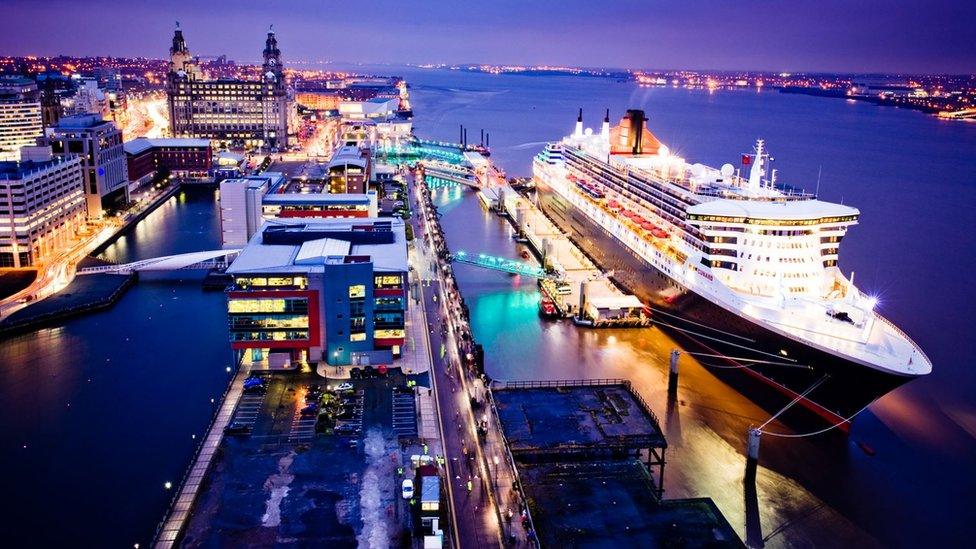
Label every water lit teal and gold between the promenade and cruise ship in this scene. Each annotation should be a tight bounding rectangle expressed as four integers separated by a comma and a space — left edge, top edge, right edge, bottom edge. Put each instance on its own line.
433, 184, 874, 545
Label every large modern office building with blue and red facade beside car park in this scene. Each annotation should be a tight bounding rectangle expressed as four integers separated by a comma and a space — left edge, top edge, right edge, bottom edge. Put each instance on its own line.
227, 219, 408, 366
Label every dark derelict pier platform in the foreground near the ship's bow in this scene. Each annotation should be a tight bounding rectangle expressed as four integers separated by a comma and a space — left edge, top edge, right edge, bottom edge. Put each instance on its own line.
492, 379, 744, 548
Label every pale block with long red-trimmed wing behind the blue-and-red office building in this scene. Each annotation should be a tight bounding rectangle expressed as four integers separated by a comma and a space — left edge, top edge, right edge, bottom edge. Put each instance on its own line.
220, 172, 378, 248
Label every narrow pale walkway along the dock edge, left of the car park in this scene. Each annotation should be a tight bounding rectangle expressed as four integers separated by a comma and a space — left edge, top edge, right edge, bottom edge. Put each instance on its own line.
154, 366, 249, 549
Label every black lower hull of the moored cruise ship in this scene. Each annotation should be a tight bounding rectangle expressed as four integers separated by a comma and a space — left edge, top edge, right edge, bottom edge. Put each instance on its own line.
537, 181, 913, 429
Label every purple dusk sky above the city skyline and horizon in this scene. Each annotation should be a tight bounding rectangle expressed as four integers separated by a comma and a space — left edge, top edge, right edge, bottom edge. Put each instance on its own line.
0, 0, 976, 73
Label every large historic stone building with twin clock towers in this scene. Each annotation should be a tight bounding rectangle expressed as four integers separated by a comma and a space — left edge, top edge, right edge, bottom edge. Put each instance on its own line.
166, 26, 289, 150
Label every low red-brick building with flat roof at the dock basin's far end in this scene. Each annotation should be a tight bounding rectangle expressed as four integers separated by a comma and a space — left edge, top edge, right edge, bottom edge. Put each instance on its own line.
122, 137, 213, 185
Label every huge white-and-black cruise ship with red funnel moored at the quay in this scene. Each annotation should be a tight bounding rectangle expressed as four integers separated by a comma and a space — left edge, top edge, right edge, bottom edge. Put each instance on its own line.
533, 110, 932, 428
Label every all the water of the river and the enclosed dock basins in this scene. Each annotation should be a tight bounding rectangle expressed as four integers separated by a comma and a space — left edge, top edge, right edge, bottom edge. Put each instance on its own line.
0, 67, 976, 547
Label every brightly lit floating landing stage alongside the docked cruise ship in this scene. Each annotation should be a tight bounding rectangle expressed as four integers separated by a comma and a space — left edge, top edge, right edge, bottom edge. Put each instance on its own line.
478, 185, 648, 327
